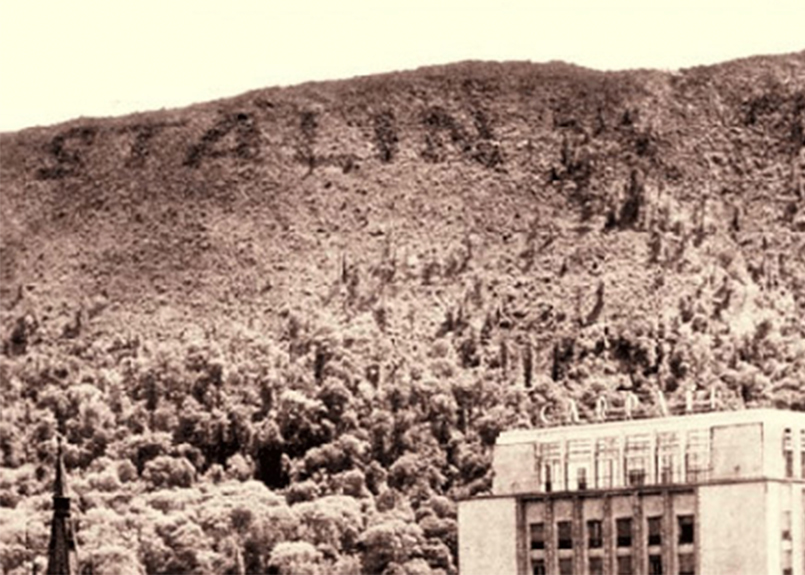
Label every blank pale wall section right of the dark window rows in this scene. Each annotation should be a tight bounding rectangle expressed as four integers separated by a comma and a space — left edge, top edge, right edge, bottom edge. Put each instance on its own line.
697, 481, 768, 575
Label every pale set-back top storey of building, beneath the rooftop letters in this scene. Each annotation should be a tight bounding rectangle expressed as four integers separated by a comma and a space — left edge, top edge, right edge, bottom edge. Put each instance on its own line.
493, 410, 805, 495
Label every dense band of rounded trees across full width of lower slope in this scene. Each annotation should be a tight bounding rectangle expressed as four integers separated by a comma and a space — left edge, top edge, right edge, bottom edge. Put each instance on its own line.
0, 268, 805, 574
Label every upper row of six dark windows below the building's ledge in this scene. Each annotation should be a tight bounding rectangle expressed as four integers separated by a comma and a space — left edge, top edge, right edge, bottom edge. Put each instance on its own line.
529, 515, 695, 550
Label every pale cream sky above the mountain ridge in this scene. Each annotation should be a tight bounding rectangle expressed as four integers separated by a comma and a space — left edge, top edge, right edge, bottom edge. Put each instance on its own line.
0, 0, 805, 131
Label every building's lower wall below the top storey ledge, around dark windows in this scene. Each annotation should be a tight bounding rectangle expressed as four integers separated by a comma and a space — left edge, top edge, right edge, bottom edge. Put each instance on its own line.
459, 481, 805, 575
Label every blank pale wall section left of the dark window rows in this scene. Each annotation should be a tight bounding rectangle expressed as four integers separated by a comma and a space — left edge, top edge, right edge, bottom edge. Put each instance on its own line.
458, 497, 522, 575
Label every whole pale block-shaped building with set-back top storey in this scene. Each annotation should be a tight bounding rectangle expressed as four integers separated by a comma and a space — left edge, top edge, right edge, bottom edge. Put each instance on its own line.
458, 409, 805, 575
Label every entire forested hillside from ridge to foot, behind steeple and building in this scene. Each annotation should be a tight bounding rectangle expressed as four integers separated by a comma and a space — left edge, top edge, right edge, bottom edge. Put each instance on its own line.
0, 52, 805, 575
